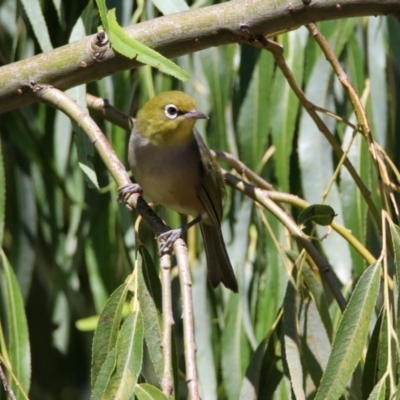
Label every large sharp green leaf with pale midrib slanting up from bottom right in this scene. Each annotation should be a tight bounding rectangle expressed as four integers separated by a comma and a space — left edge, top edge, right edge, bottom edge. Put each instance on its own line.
315, 263, 380, 400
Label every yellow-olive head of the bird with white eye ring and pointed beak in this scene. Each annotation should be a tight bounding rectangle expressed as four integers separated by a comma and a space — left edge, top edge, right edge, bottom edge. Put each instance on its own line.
136, 90, 208, 146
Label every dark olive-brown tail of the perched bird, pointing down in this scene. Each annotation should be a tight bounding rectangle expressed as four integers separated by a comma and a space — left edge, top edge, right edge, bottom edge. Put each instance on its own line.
200, 223, 238, 293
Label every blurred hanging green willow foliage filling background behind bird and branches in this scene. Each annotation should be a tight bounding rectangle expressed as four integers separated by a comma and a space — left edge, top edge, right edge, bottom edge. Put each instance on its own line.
0, 0, 400, 400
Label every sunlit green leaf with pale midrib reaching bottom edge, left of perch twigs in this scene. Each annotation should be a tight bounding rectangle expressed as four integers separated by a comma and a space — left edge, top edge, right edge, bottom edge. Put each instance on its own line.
106, 311, 144, 400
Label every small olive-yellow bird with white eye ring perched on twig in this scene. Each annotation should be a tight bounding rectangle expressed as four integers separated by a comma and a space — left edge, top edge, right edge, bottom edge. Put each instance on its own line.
121, 91, 238, 292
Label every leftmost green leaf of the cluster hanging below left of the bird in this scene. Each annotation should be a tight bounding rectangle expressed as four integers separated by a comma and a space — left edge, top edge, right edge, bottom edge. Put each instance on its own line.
92, 283, 128, 387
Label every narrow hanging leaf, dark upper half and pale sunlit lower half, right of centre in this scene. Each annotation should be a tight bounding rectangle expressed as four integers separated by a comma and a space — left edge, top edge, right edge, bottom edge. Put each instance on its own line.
282, 280, 306, 400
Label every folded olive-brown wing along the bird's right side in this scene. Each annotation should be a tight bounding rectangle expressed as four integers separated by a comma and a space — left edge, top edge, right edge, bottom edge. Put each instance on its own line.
194, 130, 225, 226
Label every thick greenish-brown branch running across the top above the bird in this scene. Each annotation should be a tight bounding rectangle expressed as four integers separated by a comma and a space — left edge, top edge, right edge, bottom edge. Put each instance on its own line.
0, 0, 400, 113
